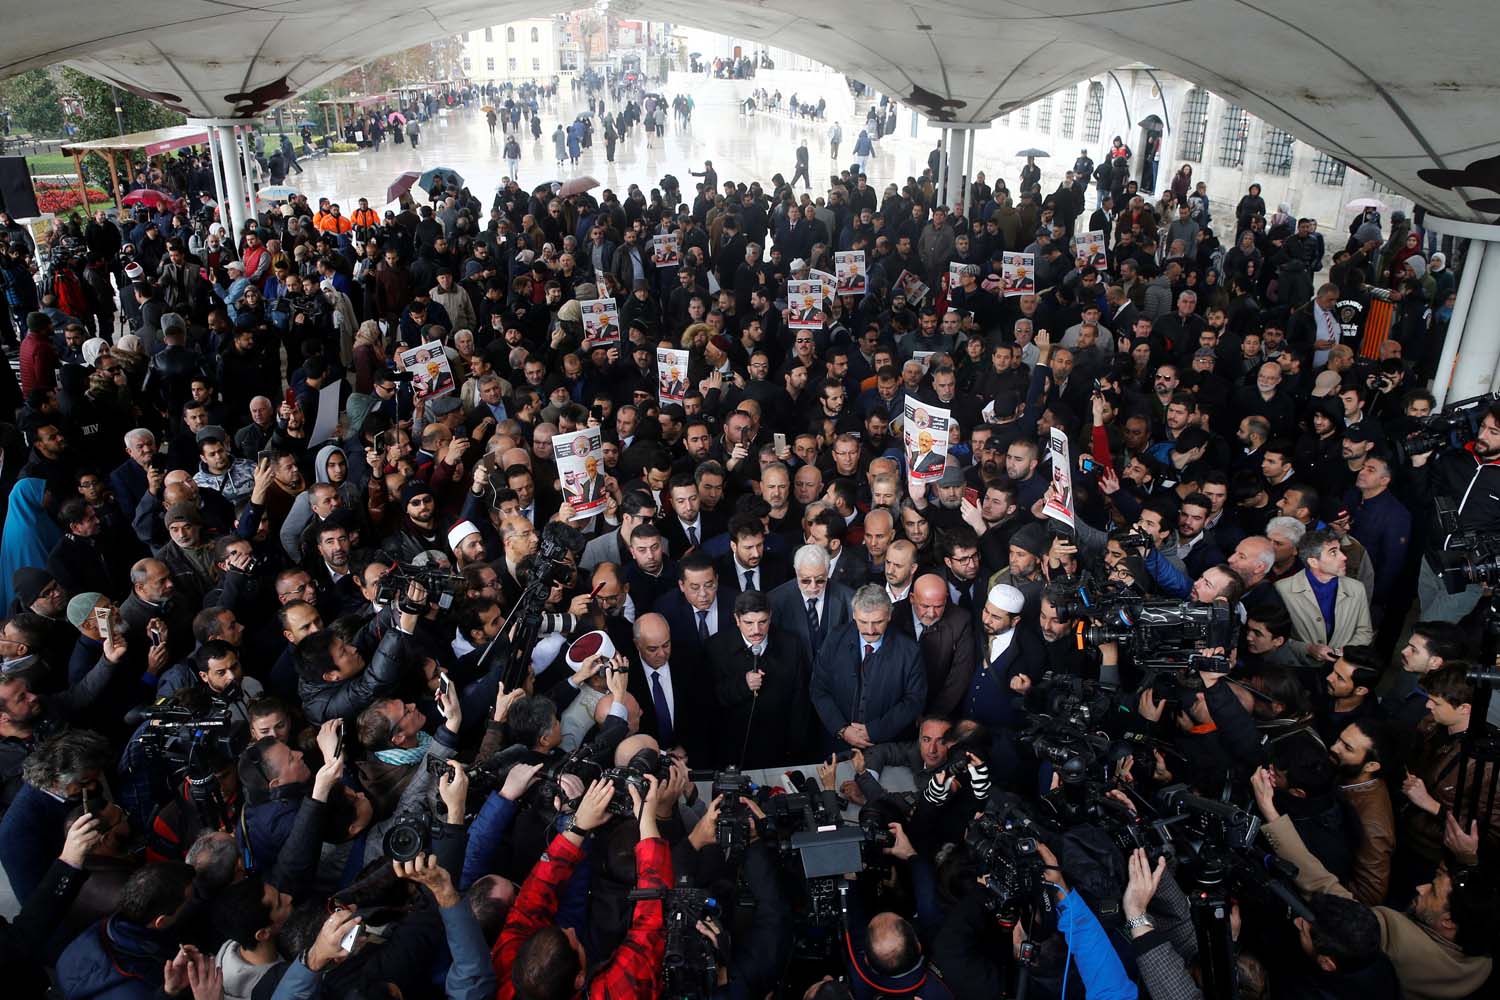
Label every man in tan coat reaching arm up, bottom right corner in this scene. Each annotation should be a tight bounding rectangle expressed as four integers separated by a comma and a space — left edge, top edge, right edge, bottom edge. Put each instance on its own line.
1251, 768, 1500, 1000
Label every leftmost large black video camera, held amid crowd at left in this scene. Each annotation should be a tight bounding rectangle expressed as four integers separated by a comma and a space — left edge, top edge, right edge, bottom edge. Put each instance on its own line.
126, 696, 251, 829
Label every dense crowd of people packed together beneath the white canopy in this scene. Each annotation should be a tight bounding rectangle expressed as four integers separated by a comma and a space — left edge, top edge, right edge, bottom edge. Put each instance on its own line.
0, 97, 1500, 1000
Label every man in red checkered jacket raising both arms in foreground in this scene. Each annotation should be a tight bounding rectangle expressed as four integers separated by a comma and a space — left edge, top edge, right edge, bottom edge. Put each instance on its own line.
492, 777, 672, 1000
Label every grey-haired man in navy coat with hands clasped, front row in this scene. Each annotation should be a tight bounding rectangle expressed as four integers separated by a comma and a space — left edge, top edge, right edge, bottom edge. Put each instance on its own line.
812, 583, 927, 750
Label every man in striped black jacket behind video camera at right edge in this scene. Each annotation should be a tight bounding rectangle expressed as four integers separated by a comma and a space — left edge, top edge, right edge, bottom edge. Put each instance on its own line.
1407, 403, 1500, 622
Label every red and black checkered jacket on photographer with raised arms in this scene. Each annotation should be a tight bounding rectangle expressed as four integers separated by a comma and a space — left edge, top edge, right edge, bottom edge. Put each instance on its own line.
491, 834, 672, 1000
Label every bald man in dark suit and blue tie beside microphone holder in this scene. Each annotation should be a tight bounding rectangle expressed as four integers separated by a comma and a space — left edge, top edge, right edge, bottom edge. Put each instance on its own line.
627, 615, 714, 760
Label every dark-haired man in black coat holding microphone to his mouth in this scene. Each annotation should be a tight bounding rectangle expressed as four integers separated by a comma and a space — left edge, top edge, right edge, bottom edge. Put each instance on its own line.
698, 591, 822, 768
